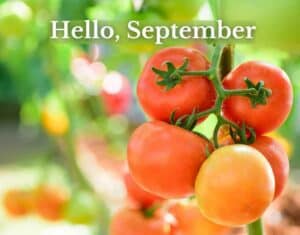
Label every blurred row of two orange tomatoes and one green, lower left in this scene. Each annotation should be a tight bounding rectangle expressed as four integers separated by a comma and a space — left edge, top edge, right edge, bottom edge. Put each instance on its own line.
3, 185, 101, 224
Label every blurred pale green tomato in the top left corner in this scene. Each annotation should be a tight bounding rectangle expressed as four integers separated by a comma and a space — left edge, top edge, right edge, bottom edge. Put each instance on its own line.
0, 1, 32, 37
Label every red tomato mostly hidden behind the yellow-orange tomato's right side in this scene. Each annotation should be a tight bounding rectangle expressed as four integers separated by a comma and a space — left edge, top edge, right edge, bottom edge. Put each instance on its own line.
251, 136, 289, 198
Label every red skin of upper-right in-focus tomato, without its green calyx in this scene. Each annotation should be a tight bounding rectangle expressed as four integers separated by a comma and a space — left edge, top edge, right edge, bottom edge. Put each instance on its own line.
223, 61, 293, 134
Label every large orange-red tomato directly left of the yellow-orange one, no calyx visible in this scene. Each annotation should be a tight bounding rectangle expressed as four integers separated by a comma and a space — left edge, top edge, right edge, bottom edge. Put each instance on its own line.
127, 121, 211, 198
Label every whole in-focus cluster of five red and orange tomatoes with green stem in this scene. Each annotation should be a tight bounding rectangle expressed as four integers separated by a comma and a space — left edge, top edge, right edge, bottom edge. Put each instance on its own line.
127, 45, 293, 231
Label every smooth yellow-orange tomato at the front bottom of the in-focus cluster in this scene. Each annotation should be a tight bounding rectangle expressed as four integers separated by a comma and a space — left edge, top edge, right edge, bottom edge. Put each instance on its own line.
195, 145, 275, 226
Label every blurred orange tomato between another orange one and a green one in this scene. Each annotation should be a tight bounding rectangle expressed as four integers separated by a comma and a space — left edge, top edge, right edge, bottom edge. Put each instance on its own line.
35, 186, 67, 221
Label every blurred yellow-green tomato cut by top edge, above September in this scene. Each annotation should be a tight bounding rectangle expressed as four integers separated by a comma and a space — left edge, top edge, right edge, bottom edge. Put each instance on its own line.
145, 0, 204, 21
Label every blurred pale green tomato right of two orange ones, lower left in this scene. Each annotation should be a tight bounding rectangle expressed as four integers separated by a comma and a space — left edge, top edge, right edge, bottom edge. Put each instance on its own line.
64, 190, 107, 224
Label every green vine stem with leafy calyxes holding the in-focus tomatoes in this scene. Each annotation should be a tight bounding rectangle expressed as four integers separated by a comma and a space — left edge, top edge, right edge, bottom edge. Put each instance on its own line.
152, 45, 272, 235
